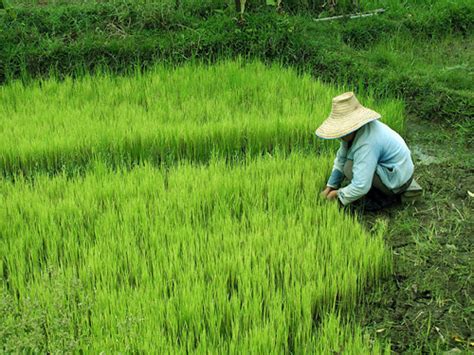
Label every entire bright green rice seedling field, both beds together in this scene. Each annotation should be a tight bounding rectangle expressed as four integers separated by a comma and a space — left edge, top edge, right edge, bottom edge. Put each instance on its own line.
0, 60, 403, 354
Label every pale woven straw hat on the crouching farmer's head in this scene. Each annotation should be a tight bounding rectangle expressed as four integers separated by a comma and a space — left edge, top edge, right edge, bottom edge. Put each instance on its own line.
316, 92, 381, 139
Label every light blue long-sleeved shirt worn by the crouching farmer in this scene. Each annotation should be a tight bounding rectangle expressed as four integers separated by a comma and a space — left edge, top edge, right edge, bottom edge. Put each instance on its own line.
327, 121, 414, 205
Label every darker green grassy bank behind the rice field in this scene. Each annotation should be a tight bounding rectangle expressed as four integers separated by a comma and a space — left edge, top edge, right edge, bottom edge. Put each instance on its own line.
0, 0, 474, 123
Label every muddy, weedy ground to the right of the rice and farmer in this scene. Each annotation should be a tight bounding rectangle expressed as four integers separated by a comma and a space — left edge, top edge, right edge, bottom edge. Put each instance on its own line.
357, 118, 474, 354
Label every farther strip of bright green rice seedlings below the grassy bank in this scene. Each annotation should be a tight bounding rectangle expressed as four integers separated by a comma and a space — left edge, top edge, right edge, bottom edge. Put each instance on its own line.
0, 60, 403, 176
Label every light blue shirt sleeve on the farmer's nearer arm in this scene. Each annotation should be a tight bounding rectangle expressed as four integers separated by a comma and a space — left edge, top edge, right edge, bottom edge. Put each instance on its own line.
337, 143, 378, 205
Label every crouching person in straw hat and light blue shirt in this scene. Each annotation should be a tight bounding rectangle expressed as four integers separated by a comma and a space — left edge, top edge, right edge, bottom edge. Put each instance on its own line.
316, 92, 414, 210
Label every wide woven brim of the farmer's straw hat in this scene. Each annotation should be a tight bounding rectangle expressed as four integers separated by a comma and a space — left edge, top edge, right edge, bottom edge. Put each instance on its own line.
316, 106, 382, 139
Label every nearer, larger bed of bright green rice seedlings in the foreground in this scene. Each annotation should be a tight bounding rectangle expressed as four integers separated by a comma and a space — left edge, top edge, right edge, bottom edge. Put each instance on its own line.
0, 154, 390, 353
